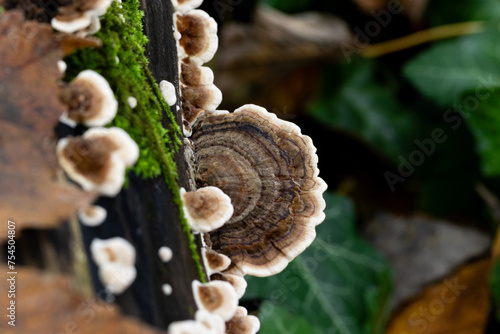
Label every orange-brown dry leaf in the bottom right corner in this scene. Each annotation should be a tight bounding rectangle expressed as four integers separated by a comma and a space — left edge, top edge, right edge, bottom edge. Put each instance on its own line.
386, 259, 491, 334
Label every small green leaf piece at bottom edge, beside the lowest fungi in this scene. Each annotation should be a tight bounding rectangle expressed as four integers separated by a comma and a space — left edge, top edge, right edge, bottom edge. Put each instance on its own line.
260, 302, 321, 334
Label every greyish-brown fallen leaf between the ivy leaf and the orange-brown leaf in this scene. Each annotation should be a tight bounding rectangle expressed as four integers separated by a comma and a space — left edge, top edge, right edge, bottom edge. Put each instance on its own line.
364, 214, 491, 308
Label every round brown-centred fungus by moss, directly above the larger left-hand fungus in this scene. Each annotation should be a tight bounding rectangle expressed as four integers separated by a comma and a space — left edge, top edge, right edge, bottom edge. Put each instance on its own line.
59, 70, 118, 126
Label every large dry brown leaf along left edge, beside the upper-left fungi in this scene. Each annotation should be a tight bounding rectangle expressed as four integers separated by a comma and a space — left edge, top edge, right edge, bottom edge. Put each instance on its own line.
0, 11, 95, 240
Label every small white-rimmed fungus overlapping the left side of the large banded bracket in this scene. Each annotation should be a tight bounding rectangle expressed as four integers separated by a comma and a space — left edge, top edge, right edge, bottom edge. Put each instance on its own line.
181, 187, 233, 232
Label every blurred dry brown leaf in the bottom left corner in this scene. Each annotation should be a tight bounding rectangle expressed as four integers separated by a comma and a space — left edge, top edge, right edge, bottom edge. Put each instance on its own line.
0, 266, 164, 334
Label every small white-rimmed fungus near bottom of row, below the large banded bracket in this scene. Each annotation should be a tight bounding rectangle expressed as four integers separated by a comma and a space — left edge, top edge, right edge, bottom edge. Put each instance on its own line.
192, 281, 238, 321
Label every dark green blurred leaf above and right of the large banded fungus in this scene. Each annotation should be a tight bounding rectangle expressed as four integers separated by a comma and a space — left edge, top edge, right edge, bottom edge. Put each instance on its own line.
310, 61, 424, 164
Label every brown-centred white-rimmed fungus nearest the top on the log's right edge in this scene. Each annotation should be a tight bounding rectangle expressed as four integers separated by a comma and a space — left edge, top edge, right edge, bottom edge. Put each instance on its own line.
174, 9, 219, 65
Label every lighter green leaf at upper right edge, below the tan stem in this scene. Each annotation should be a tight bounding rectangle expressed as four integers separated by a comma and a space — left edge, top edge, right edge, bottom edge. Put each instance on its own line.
404, 30, 500, 107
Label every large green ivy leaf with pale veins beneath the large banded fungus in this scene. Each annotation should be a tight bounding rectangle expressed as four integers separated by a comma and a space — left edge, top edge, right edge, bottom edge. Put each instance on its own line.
246, 194, 391, 334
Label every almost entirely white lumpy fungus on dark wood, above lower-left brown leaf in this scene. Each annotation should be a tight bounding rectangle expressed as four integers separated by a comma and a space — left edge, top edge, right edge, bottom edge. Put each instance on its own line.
90, 237, 137, 294
